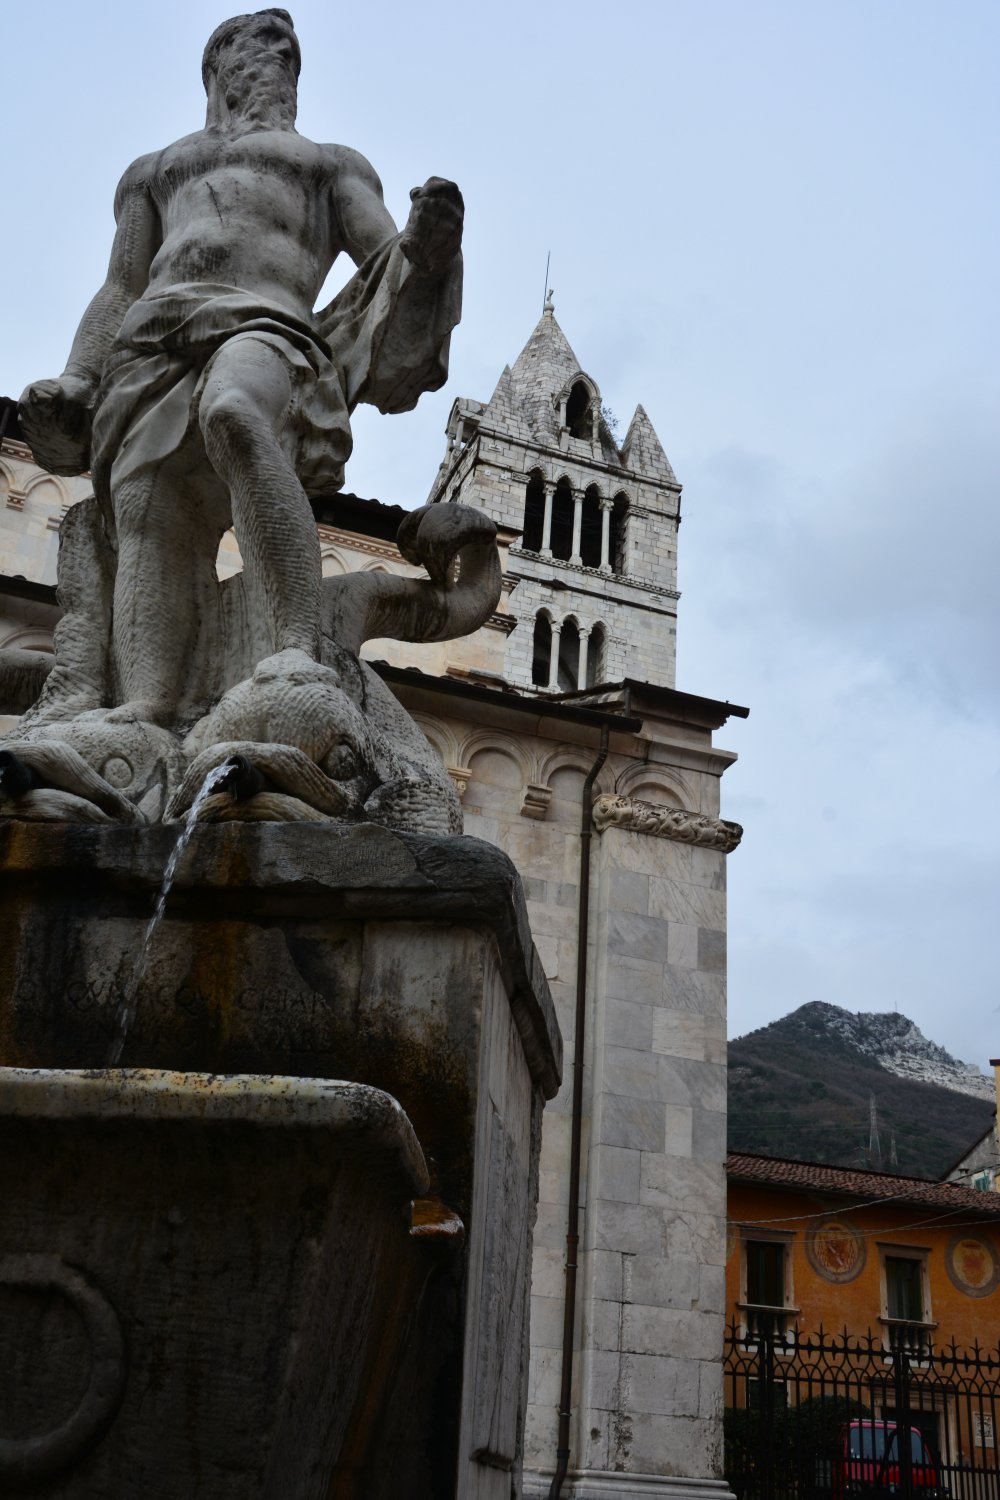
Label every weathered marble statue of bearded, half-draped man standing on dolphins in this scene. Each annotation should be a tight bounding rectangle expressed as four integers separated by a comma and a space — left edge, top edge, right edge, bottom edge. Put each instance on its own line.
3, 9, 499, 825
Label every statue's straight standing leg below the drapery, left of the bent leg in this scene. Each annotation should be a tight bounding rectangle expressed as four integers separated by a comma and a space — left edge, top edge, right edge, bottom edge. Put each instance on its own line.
111, 462, 226, 728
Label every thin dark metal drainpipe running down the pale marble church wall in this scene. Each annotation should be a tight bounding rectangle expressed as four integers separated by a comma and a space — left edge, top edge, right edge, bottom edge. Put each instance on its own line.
549, 725, 609, 1500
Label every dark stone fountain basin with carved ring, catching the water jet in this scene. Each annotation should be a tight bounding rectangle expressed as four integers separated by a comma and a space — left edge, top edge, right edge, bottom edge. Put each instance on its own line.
0, 1068, 427, 1500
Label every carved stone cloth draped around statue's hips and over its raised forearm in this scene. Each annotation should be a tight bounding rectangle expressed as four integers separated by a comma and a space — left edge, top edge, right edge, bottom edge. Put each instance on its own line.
90, 236, 462, 519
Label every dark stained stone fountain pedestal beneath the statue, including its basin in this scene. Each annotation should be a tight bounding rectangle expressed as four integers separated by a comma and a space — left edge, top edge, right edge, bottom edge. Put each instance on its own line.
0, 824, 559, 1500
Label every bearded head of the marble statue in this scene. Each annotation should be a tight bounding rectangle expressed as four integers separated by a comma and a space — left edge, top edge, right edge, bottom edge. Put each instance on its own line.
201, 11, 301, 125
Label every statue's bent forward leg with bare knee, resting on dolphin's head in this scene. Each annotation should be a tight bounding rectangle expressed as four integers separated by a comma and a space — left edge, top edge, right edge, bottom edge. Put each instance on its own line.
199, 345, 322, 660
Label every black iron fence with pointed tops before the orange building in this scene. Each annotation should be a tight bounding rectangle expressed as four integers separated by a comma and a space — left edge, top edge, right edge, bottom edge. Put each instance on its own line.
726, 1310, 1000, 1500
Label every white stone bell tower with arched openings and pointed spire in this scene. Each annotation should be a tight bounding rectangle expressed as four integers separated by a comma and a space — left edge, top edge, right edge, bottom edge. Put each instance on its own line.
429, 294, 681, 693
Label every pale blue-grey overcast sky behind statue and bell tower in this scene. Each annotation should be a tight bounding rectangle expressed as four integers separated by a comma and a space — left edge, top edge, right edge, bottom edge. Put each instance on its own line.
0, 0, 1000, 1067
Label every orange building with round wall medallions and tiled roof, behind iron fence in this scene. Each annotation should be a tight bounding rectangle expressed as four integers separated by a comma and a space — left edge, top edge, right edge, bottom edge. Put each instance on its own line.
726, 1154, 1000, 1500
